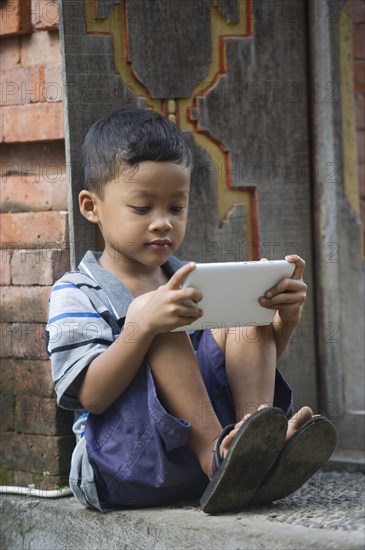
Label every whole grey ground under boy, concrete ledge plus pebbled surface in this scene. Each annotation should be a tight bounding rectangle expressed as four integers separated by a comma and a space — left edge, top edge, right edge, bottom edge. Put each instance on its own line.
0, 471, 365, 550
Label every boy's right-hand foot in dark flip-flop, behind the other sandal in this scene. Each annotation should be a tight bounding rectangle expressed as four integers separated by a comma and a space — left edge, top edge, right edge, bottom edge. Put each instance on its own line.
250, 414, 337, 504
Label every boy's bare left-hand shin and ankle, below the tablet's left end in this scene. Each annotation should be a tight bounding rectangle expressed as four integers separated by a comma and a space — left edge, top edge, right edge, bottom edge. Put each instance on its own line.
148, 332, 242, 477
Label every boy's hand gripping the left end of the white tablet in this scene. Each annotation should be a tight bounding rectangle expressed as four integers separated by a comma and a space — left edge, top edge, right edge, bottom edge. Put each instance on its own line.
126, 262, 203, 335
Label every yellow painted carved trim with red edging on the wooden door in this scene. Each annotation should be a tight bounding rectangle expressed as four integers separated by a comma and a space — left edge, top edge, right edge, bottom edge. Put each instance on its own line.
84, 0, 253, 246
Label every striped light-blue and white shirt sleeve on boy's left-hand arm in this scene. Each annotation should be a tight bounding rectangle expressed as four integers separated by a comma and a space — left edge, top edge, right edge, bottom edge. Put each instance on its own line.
46, 279, 116, 410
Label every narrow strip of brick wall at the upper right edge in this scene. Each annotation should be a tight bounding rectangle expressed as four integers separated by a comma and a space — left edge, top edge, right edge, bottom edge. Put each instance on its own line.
351, 0, 365, 235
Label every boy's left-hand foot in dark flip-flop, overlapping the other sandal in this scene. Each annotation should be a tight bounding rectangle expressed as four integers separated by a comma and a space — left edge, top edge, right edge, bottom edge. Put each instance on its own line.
200, 407, 288, 514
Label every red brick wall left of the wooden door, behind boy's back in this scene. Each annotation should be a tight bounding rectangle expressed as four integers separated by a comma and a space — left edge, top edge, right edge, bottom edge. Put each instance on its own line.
0, 0, 74, 488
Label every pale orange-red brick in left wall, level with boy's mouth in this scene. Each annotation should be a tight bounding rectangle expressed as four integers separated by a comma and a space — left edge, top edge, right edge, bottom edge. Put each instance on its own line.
0, 212, 67, 249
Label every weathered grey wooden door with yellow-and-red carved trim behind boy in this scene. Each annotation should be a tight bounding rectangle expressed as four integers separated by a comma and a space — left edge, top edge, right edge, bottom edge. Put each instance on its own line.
61, 0, 317, 407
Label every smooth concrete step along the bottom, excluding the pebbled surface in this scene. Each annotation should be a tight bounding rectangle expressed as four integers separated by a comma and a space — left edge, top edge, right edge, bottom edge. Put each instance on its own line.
0, 488, 364, 550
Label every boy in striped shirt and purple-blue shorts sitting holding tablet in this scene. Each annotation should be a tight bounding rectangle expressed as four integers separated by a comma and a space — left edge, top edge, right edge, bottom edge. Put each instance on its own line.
47, 109, 336, 513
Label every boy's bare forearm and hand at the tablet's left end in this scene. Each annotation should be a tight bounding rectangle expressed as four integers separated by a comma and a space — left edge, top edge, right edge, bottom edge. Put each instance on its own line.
76, 263, 202, 414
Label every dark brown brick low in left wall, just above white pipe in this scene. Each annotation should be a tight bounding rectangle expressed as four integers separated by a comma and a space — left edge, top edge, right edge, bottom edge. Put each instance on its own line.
0, 433, 75, 475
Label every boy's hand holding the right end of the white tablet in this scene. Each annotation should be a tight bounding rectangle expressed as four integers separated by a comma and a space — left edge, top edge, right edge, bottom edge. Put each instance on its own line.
259, 254, 307, 324
